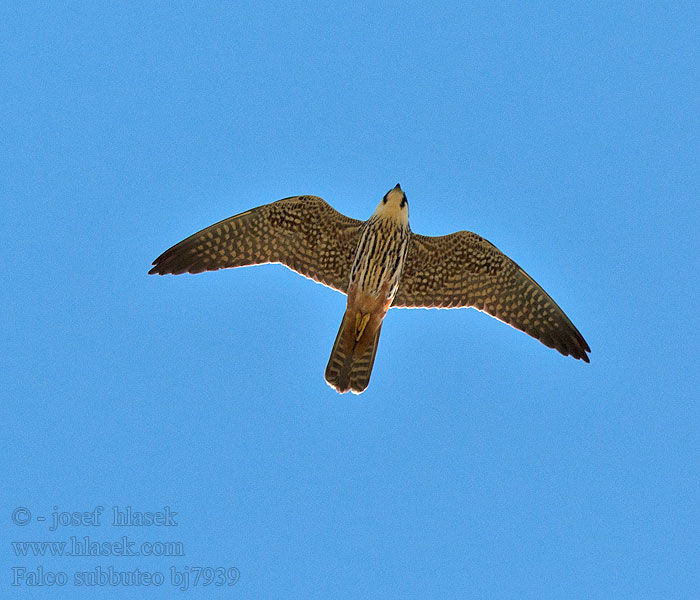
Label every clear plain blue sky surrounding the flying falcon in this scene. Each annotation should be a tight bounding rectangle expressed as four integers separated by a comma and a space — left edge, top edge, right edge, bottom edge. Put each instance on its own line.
0, 1, 700, 598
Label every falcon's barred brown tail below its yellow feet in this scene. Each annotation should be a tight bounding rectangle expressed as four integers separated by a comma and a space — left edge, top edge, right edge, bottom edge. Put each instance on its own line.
326, 311, 382, 394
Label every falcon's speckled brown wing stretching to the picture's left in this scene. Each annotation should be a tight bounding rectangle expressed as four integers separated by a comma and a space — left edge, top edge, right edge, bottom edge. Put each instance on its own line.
149, 196, 362, 293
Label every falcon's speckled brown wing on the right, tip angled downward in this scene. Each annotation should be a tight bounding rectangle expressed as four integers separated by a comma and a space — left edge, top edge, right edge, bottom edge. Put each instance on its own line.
392, 231, 591, 362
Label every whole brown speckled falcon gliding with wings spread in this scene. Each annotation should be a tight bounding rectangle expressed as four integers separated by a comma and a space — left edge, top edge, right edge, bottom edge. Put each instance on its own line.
149, 184, 591, 394
